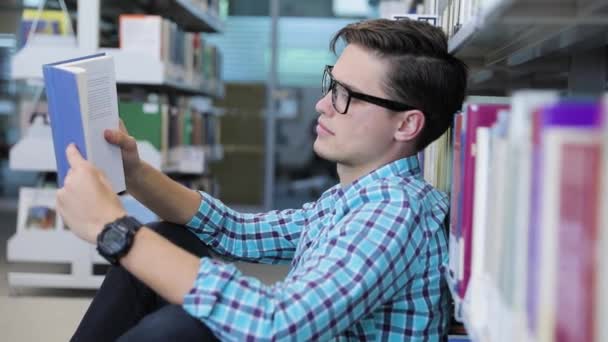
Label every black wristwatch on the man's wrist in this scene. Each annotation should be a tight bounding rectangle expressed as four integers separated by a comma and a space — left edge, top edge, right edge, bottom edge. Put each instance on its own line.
97, 216, 143, 265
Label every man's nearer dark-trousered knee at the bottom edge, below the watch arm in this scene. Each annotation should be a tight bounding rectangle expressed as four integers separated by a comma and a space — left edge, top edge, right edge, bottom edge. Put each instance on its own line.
118, 305, 217, 342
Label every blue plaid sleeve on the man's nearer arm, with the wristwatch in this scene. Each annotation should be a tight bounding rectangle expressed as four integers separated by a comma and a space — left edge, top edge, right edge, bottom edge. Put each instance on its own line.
183, 203, 423, 341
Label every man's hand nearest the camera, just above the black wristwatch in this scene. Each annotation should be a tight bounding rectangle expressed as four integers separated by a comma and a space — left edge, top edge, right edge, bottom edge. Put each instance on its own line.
57, 144, 126, 243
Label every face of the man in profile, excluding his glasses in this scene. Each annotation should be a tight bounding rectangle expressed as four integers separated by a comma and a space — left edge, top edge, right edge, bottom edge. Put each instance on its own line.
314, 44, 399, 167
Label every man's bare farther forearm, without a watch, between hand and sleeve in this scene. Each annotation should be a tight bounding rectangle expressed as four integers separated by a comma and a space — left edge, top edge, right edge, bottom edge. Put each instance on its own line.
127, 161, 201, 224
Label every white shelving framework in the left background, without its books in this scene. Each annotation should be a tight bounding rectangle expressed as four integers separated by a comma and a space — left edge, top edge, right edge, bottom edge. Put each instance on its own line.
7, 0, 224, 289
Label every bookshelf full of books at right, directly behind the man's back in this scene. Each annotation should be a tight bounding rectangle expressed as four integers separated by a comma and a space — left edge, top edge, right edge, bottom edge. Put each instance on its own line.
419, 0, 608, 341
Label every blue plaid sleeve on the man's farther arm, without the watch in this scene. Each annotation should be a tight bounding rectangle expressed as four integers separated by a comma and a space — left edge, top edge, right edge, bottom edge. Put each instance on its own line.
186, 192, 317, 264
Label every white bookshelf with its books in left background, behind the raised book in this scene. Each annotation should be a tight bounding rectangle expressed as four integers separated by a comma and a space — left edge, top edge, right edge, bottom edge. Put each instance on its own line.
7, 0, 224, 289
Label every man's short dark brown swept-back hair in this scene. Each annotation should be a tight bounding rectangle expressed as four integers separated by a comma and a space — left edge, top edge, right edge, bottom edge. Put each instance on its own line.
330, 19, 468, 150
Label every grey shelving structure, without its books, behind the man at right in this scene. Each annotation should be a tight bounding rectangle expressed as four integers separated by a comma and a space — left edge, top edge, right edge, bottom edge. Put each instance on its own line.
435, 0, 608, 341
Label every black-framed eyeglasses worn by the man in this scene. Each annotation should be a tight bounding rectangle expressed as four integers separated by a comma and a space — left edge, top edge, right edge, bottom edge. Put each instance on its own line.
321, 65, 417, 114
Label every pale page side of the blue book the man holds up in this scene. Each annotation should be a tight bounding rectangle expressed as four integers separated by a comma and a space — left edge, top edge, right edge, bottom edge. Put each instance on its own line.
61, 56, 126, 192
